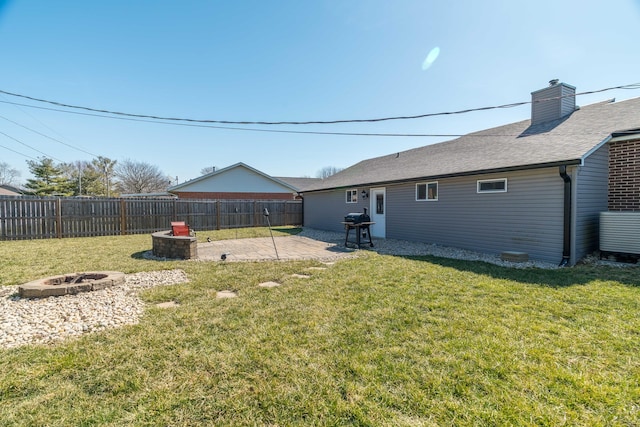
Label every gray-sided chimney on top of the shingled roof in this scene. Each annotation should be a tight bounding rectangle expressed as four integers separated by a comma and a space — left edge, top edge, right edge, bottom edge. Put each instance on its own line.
531, 79, 576, 125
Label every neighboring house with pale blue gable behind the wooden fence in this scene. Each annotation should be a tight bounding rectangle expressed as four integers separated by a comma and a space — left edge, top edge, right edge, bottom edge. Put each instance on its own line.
168, 163, 308, 200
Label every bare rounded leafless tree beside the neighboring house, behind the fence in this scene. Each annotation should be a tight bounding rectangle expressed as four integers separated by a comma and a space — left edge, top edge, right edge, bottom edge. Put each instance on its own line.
114, 159, 171, 194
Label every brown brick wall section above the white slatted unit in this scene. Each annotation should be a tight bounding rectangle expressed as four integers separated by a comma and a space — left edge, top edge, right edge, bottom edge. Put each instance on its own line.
609, 139, 640, 212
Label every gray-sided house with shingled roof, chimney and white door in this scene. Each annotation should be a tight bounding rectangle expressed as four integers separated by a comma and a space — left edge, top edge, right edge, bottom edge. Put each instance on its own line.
304, 81, 640, 265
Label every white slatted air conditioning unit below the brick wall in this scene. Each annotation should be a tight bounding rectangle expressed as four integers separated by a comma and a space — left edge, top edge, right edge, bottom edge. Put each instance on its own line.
600, 212, 640, 254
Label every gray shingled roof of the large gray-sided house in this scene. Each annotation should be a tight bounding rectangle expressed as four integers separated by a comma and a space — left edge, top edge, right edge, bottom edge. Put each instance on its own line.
306, 98, 640, 191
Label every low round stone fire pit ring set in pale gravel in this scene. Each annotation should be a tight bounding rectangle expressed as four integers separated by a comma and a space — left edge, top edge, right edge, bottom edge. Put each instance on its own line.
18, 271, 124, 298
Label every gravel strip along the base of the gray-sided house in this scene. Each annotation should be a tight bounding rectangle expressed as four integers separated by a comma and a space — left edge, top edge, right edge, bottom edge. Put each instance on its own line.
299, 228, 558, 269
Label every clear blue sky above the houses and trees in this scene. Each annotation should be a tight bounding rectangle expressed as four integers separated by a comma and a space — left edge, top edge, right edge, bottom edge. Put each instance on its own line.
0, 0, 640, 186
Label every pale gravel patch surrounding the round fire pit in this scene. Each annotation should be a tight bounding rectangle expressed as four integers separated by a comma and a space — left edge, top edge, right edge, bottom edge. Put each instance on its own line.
0, 270, 189, 348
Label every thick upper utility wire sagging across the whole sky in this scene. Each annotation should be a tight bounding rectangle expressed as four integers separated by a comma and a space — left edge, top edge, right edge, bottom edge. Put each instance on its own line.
0, 83, 640, 125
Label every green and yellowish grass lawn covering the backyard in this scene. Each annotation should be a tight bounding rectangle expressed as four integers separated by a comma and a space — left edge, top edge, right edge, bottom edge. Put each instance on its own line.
0, 229, 640, 426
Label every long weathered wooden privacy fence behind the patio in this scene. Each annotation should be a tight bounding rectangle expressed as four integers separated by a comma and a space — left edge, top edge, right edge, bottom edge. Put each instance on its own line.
0, 197, 302, 240
